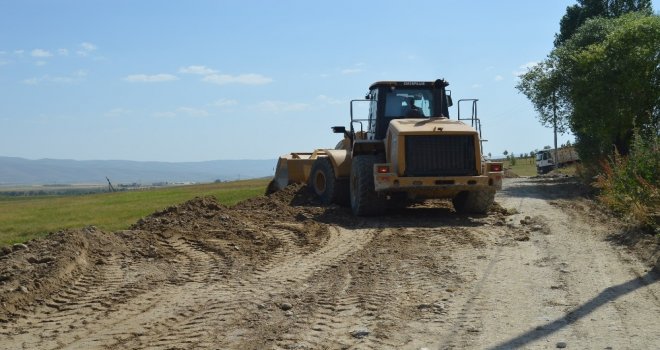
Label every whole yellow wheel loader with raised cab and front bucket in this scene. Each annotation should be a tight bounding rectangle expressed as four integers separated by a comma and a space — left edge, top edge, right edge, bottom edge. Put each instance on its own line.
267, 79, 503, 216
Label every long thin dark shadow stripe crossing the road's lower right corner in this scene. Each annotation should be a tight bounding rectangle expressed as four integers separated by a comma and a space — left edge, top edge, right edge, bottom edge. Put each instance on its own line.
491, 270, 660, 349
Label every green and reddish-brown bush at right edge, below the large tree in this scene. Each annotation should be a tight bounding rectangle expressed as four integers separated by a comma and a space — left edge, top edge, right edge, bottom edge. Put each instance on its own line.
595, 132, 660, 227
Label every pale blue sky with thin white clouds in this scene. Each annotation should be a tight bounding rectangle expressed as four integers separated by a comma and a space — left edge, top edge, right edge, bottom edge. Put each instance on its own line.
0, 0, 648, 162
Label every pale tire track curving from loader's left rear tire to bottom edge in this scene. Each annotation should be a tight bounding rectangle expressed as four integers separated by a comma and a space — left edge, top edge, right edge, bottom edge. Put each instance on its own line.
97, 227, 373, 348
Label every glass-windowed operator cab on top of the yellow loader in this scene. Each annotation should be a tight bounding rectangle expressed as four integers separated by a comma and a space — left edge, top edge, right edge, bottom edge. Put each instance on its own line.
352, 79, 452, 141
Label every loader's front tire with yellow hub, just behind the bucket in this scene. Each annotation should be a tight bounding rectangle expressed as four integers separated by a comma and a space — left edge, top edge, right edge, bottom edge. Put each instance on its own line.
307, 157, 348, 204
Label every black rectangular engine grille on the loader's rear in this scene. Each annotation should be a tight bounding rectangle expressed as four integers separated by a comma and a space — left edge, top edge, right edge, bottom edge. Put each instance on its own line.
404, 135, 477, 176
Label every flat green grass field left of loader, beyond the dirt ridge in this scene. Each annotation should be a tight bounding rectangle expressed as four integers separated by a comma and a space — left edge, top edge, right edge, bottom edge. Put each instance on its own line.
0, 179, 269, 246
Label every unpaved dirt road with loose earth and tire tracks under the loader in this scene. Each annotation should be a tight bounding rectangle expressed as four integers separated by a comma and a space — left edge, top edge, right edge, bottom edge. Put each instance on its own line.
0, 179, 660, 349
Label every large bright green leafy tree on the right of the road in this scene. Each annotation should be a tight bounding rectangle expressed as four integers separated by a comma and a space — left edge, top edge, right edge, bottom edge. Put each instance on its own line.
516, 11, 660, 164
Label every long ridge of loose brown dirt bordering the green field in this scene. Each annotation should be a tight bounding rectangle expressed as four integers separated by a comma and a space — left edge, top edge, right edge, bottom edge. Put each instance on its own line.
0, 191, 328, 322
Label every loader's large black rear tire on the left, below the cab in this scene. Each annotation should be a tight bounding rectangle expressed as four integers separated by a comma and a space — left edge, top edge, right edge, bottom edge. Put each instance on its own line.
350, 155, 387, 216
